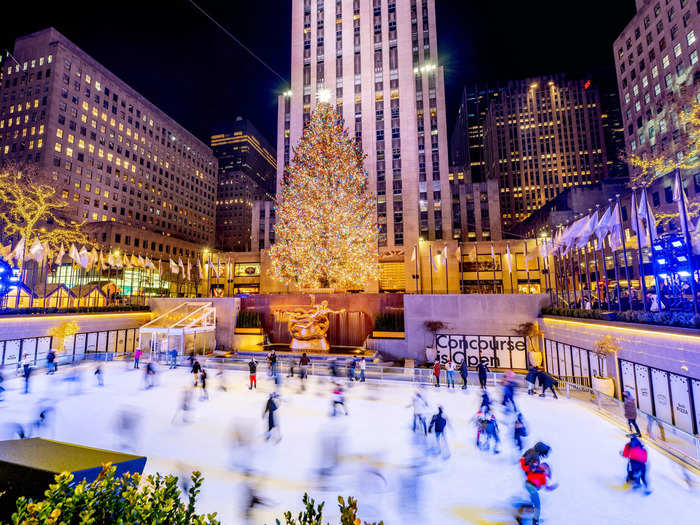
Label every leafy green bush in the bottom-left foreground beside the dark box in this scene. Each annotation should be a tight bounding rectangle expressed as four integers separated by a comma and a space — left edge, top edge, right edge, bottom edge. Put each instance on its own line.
12, 466, 220, 525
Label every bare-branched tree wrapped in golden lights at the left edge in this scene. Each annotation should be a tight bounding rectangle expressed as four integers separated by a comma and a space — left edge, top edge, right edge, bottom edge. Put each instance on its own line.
0, 164, 92, 250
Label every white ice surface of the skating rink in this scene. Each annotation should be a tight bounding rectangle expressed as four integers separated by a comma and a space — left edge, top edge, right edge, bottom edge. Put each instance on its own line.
0, 362, 700, 525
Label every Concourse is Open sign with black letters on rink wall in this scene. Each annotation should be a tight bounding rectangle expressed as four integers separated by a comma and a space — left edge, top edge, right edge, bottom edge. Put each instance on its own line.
435, 334, 527, 370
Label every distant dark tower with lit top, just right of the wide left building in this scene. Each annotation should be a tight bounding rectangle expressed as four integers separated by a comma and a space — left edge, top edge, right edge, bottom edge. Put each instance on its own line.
211, 117, 277, 252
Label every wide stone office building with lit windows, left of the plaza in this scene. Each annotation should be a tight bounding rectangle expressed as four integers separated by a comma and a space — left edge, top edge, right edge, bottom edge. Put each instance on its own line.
0, 28, 217, 258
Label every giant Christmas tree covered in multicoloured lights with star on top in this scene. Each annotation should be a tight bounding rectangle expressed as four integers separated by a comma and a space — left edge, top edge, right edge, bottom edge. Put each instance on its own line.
270, 103, 379, 289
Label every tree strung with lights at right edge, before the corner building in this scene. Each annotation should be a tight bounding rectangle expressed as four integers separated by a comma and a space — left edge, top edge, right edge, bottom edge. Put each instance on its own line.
626, 86, 700, 187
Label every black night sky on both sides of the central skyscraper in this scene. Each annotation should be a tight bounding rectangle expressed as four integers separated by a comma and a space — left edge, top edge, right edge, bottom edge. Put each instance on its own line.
0, 0, 635, 148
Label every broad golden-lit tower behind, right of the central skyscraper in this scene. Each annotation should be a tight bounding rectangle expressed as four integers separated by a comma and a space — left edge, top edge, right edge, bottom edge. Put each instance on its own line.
484, 75, 608, 230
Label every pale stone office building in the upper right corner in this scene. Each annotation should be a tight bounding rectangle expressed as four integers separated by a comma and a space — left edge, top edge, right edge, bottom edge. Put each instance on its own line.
613, 0, 700, 166
